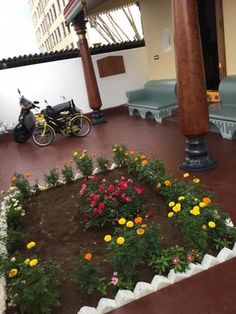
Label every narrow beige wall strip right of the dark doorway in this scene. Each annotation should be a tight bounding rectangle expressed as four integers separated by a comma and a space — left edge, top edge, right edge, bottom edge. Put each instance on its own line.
223, 0, 236, 75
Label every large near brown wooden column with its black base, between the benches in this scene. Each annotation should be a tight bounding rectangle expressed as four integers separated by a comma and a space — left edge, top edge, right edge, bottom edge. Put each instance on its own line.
172, 0, 215, 171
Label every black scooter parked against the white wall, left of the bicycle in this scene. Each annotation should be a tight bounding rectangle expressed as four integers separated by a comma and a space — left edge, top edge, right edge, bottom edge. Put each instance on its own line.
13, 89, 39, 144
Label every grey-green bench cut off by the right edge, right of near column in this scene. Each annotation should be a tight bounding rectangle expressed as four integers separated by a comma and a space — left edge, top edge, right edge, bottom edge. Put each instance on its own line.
209, 75, 236, 140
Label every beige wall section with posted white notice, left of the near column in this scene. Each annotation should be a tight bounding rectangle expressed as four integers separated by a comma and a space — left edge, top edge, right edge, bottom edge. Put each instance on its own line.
139, 0, 176, 79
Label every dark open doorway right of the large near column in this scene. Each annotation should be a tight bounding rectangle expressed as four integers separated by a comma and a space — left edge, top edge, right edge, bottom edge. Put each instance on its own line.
197, 0, 224, 90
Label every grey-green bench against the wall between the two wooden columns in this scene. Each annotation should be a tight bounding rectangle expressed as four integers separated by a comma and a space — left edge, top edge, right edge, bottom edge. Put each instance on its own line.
126, 80, 177, 123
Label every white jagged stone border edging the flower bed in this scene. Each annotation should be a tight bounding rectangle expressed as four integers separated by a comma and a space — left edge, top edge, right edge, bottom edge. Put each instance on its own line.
0, 163, 236, 314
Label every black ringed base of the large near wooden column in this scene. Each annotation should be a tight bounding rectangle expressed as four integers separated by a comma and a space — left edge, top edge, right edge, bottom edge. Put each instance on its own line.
180, 136, 216, 172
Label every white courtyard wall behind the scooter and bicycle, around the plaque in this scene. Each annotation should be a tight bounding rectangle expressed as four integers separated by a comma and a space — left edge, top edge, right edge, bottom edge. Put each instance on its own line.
0, 47, 148, 127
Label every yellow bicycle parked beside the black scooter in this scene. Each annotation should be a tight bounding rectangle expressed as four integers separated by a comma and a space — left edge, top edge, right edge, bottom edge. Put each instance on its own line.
32, 100, 91, 147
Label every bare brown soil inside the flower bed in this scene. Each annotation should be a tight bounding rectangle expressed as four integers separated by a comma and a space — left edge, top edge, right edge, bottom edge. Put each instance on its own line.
8, 169, 183, 314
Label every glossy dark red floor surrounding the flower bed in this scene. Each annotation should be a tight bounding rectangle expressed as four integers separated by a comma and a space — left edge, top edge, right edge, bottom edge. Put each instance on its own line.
0, 106, 236, 314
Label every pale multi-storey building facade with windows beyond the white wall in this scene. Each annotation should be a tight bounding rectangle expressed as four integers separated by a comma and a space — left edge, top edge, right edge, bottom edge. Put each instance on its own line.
28, 0, 76, 52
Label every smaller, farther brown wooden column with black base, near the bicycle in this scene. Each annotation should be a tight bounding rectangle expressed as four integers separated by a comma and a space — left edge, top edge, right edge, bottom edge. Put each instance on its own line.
72, 11, 106, 125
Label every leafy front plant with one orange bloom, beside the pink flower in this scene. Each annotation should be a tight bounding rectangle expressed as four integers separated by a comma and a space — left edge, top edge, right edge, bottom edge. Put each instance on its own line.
72, 252, 107, 295
